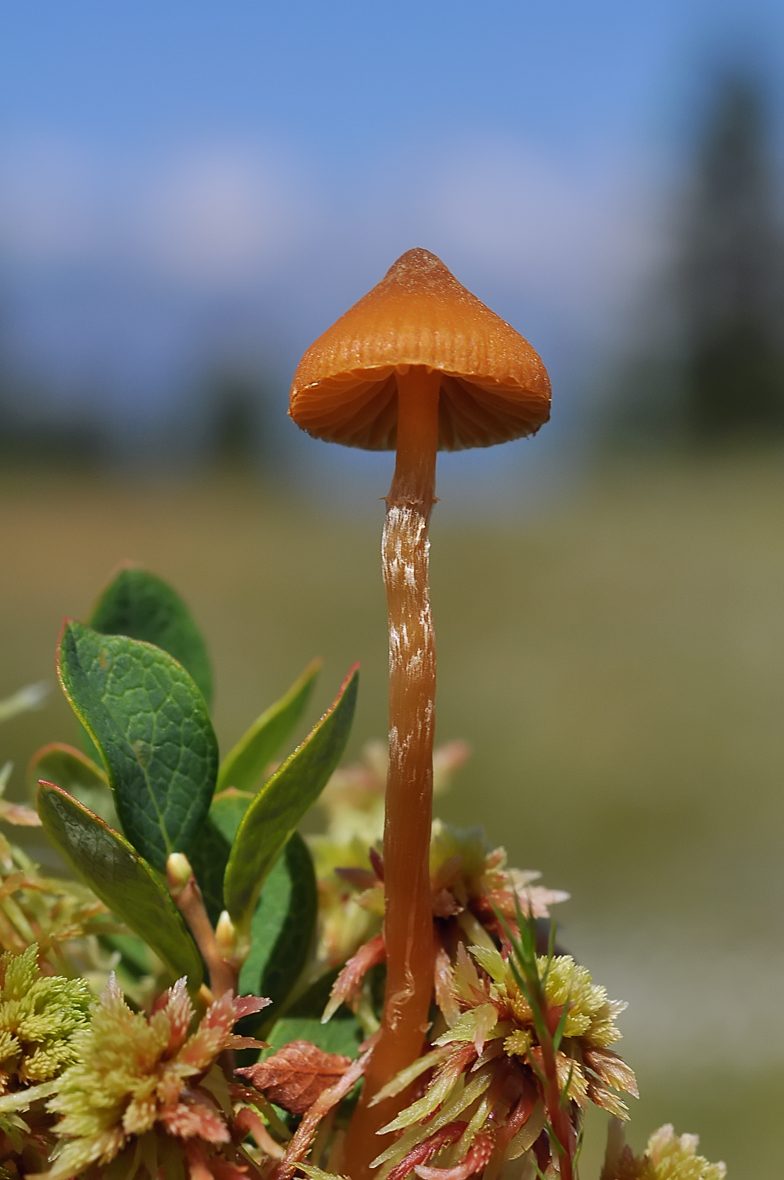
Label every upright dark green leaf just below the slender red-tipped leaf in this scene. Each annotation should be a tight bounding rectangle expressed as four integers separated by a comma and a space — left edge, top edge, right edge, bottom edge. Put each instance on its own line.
240, 832, 319, 1008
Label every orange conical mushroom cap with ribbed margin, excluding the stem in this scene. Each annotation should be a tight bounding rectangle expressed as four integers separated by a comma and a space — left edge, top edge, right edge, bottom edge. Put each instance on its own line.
289, 248, 550, 451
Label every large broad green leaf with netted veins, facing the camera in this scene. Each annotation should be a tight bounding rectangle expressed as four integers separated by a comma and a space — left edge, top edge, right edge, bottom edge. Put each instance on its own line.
58, 623, 217, 872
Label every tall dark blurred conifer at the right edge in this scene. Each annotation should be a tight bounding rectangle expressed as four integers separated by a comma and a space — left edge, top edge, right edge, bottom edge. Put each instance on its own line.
677, 76, 784, 441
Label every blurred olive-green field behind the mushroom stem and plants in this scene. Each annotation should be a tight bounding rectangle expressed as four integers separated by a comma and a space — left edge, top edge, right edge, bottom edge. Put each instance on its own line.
0, 454, 784, 1180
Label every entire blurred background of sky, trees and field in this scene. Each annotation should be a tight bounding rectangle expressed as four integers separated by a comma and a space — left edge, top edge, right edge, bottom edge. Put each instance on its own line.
0, 0, 784, 1180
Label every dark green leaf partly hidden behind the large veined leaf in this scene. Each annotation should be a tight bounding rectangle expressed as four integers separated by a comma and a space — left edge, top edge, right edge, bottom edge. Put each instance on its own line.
87, 565, 213, 706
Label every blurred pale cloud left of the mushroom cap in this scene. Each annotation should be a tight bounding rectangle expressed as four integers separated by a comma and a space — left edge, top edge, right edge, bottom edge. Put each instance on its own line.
0, 139, 311, 289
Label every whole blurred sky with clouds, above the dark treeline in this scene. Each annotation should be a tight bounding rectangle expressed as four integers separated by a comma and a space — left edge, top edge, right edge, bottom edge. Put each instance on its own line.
0, 0, 784, 469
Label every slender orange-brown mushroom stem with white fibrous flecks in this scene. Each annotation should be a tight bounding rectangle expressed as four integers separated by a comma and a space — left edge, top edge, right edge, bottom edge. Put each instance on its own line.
346, 366, 442, 1180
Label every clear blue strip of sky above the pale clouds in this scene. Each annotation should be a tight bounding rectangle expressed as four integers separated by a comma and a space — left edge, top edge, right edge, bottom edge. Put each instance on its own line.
0, 0, 784, 156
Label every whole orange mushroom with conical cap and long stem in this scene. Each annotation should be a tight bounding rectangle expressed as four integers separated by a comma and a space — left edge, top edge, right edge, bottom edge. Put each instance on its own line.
289, 249, 550, 1180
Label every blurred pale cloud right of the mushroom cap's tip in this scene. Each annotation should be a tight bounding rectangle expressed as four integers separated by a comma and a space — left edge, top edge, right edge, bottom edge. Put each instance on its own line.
410, 136, 662, 330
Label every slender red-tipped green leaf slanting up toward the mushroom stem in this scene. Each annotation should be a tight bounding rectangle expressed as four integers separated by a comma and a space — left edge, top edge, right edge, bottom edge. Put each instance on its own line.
223, 668, 359, 935
